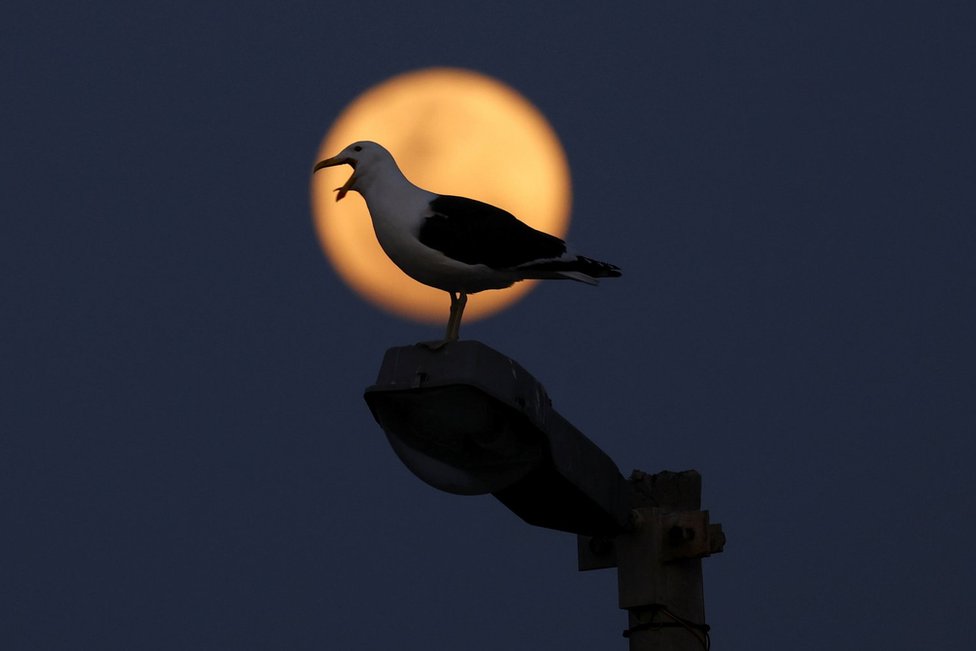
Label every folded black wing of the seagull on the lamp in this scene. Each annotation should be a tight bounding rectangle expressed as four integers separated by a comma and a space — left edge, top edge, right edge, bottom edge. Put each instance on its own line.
418, 195, 566, 269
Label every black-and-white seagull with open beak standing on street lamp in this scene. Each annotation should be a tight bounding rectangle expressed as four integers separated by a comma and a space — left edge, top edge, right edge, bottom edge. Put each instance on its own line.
312, 140, 620, 343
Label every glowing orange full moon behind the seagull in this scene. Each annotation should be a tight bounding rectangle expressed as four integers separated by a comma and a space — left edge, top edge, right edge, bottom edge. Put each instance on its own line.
311, 68, 571, 323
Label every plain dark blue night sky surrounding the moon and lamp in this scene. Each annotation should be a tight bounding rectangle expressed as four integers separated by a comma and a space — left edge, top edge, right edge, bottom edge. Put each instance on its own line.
0, 1, 976, 650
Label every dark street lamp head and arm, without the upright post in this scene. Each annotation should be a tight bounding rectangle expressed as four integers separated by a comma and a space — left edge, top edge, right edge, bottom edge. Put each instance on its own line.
365, 341, 631, 536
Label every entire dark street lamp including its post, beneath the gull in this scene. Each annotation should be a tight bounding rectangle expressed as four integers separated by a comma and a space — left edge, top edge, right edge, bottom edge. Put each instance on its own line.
365, 341, 724, 651
